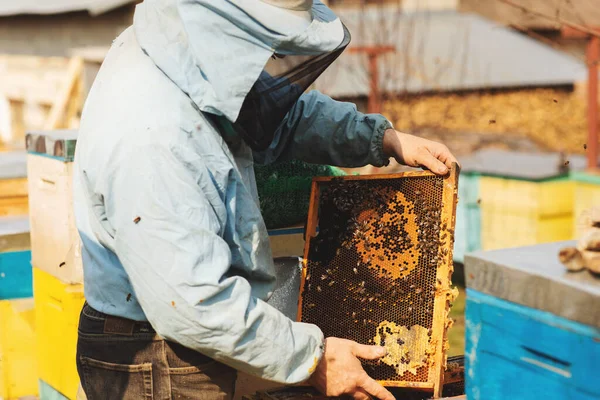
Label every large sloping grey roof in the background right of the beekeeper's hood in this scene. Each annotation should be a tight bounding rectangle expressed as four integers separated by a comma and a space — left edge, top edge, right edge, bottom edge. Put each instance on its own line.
316, 6, 587, 97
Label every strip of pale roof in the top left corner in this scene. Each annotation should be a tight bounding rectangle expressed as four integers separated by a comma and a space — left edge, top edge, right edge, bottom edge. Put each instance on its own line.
0, 0, 136, 16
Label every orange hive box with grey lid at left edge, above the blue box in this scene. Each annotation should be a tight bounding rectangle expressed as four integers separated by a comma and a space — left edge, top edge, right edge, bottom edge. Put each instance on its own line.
0, 151, 29, 217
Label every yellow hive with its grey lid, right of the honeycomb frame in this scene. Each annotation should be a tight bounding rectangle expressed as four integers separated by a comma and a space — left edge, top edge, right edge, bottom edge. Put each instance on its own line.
463, 150, 585, 250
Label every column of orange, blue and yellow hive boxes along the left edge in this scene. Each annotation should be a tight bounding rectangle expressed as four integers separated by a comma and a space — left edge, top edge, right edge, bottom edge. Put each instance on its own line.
0, 151, 37, 399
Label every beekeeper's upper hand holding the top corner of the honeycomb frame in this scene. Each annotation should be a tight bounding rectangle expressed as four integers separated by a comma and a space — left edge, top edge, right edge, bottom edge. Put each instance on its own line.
383, 129, 458, 175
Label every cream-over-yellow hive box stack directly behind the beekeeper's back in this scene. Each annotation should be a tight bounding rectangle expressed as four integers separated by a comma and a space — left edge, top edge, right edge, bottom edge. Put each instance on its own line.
26, 131, 84, 400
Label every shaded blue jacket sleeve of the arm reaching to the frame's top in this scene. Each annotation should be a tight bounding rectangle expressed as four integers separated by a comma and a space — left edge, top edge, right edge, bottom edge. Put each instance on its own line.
254, 90, 392, 167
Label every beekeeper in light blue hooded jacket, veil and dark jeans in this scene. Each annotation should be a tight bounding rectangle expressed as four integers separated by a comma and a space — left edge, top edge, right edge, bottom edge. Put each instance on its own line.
74, 0, 455, 400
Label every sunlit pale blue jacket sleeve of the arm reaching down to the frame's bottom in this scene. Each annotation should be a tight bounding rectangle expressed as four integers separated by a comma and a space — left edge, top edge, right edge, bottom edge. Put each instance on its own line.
110, 146, 323, 384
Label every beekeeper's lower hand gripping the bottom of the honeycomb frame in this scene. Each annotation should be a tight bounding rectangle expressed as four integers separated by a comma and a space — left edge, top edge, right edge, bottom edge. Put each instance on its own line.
308, 337, 394, 400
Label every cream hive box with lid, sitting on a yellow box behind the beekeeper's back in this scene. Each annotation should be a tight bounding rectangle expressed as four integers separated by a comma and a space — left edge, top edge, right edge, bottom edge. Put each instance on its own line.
26, 131, 83, 283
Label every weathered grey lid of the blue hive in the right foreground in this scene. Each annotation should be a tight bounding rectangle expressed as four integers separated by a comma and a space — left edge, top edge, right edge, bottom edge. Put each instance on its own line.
465, 241, 600, 328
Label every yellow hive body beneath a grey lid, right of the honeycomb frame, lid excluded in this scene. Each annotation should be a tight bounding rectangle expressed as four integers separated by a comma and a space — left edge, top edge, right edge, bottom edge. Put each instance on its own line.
480, 177, 575, 250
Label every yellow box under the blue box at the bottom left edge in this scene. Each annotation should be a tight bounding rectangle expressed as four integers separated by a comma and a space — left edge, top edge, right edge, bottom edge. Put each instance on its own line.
0, 299, 38, 400
